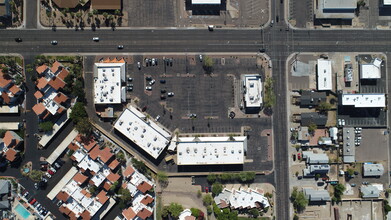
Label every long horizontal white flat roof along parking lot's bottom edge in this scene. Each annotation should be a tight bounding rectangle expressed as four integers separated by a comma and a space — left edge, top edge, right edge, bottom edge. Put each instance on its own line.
177, 136, 247, 165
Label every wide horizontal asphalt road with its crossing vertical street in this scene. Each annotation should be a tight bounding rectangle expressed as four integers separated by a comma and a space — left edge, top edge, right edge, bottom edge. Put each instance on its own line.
0, 1, 391, 219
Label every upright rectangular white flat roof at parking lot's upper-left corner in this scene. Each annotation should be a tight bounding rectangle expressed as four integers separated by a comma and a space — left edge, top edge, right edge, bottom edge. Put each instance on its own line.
94, 63, 126, 104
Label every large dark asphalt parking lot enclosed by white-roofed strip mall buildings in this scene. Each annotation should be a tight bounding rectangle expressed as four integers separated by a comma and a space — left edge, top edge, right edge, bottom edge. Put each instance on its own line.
128, 55, 272, 171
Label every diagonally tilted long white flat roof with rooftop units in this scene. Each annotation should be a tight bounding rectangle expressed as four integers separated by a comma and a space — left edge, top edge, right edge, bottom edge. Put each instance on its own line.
114, 106, 171, 159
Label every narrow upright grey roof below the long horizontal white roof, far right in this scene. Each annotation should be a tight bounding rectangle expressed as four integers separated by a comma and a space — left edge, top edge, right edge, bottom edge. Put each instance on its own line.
342, 127, 356, 163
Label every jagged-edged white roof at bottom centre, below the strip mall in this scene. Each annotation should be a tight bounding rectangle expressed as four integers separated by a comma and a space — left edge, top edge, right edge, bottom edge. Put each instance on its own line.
214, 188, 270, 210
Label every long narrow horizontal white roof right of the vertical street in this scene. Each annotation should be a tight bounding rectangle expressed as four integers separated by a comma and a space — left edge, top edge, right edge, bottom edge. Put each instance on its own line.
342, 93, 386, 108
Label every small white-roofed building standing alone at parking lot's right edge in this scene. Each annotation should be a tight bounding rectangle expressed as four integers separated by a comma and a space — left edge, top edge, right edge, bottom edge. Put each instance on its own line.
244, 75, 262, 108
